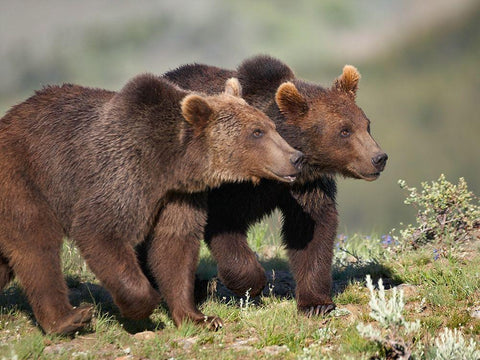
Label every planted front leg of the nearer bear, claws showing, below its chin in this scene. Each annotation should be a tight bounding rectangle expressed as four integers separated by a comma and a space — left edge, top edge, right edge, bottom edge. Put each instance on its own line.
147, 193, 223, 330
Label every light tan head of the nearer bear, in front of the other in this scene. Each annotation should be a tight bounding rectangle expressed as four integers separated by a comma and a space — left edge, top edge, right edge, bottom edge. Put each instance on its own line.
181, 78, 303, 183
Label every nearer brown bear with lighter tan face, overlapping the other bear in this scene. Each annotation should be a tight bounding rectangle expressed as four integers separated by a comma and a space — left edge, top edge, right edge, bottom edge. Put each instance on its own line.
0, 74, 302, 333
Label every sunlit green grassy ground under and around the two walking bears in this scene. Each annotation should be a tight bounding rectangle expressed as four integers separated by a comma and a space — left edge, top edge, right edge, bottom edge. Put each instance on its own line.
0, 224, 480, 359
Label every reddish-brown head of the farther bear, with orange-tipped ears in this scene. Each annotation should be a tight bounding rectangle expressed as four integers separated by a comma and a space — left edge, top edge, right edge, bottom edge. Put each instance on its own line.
275, 65, 388, 181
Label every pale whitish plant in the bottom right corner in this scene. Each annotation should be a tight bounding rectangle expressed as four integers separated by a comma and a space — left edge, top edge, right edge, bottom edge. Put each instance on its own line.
433, 328, 480, 360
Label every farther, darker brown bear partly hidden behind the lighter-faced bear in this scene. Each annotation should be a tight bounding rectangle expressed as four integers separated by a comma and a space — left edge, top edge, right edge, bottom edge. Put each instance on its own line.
157, 56, 387, 316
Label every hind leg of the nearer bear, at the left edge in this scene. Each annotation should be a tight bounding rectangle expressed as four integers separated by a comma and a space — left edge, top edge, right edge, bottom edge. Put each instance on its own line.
0, 177, 92, 334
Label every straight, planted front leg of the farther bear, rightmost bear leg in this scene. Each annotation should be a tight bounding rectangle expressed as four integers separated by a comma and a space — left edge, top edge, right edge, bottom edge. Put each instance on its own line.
283, 181, 338, 316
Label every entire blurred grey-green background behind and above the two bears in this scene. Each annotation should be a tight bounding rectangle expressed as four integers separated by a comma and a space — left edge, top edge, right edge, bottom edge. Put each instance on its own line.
0, 0, 480, 233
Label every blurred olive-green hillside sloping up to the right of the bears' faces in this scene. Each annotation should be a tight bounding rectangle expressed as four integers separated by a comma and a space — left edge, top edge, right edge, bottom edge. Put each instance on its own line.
339, 4, 480, 231
